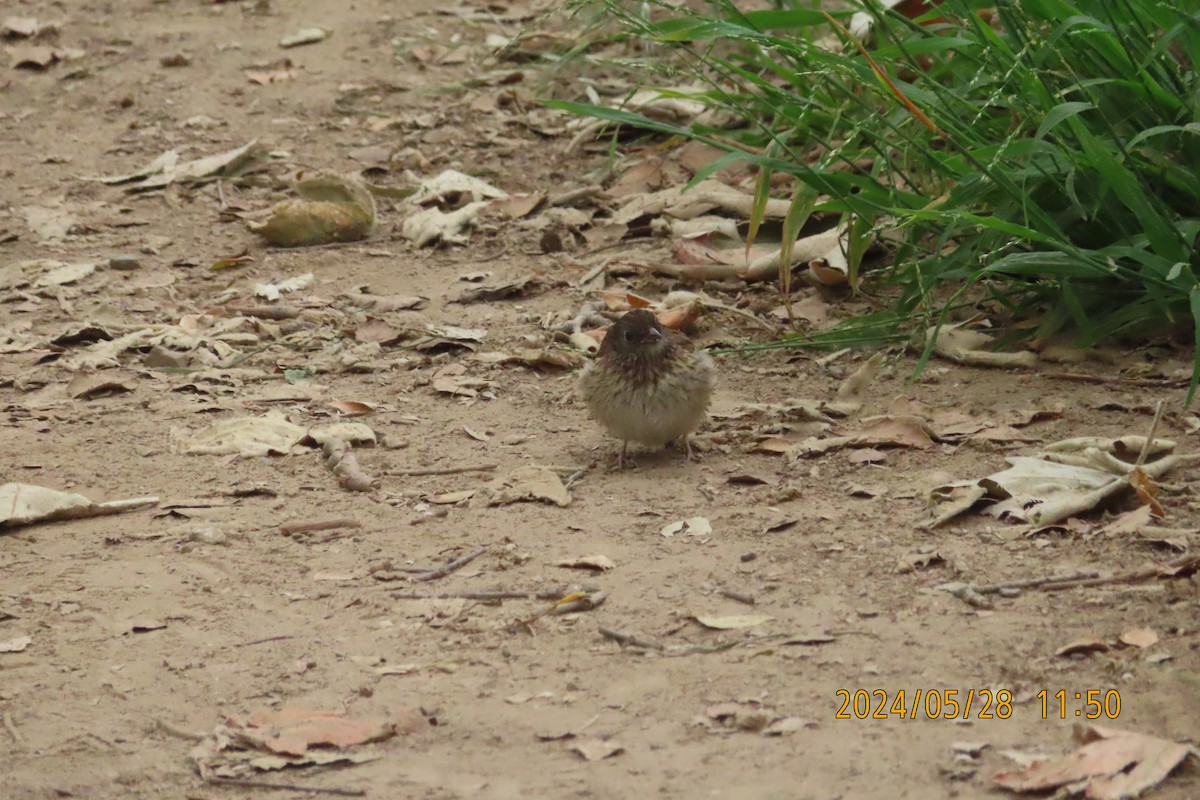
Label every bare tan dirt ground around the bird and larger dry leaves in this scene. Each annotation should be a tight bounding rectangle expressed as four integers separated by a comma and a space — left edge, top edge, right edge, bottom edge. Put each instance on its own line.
0, 0, 1200, 800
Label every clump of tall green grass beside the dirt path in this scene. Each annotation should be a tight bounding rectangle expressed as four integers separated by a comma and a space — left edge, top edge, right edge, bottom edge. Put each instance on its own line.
554, 0, 1200, 403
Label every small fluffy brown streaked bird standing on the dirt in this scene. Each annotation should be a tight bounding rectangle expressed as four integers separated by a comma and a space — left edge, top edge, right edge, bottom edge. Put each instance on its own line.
580, 308, 716, 469
